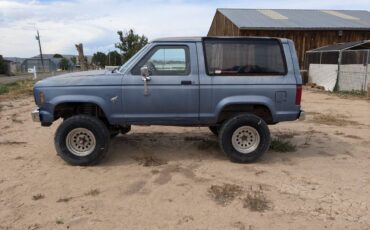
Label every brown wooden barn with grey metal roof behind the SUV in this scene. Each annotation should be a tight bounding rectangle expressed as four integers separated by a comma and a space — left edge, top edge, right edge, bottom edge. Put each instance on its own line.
208, 9, 370, 68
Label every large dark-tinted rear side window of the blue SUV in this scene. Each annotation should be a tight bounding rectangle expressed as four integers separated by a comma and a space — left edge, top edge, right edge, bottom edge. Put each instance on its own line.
203, 38, 287, 76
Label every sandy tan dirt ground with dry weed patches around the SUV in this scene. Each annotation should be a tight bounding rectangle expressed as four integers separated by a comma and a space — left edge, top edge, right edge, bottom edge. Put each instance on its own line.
0, 90, 370, 230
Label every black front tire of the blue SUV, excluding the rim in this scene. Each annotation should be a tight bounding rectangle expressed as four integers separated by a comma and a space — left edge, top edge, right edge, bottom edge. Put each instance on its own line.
54, 115, 110, 166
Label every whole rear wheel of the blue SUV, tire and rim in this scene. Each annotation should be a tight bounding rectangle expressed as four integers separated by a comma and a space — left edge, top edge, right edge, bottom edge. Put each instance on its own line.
219, 113, 271, 163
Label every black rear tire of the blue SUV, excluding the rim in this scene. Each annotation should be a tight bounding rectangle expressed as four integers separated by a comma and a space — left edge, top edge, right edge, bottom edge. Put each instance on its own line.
219, 113, 271, 163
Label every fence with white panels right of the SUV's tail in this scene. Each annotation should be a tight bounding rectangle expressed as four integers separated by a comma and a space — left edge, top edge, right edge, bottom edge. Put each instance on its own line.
305, 50, 370, 91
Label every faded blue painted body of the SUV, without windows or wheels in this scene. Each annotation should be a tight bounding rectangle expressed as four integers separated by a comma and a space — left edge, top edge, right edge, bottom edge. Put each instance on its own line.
34, 38, 302, 125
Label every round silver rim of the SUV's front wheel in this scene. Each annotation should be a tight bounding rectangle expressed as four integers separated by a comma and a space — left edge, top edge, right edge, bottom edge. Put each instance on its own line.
66, 128, 96, 157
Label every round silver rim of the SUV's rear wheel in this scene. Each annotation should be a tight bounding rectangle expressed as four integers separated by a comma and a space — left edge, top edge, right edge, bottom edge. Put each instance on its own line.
231, 126, 261, 154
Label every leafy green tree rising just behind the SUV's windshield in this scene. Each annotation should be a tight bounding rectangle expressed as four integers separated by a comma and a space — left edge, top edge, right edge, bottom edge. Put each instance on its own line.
116, 29, 148, 63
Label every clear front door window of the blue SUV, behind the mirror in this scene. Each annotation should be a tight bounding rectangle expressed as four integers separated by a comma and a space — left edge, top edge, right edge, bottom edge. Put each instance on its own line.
132, 46, 190, 76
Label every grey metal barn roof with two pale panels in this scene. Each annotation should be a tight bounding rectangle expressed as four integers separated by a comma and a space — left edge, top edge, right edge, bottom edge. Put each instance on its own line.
217, 9, 370, 30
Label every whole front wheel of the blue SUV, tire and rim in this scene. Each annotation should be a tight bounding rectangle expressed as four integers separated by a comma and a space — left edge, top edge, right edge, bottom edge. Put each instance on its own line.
54, 115, 110, 165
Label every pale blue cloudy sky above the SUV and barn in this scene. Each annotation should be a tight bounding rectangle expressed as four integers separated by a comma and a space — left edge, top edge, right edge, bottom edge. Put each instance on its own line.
0, 0, 370, 57
